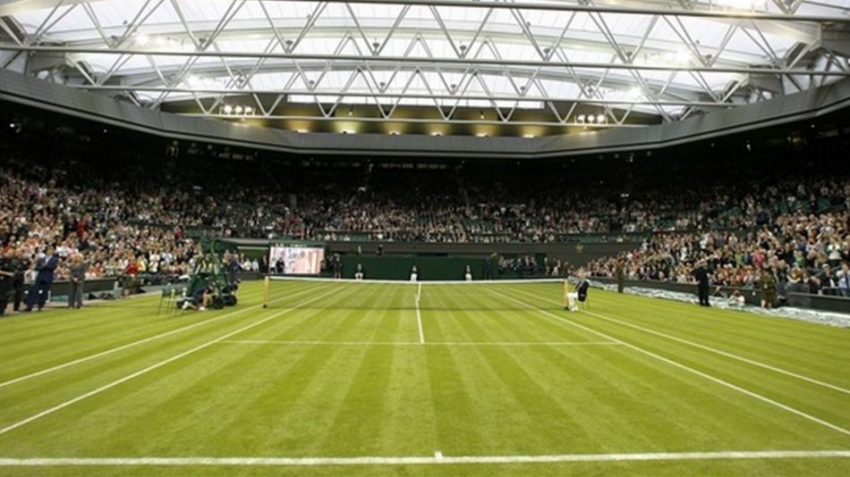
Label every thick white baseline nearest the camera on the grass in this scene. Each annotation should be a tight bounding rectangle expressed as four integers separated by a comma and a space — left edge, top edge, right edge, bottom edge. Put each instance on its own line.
0, 450, 850, 467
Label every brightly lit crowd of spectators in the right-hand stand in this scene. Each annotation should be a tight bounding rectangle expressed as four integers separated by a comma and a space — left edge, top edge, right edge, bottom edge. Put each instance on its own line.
588, 180, 850, 297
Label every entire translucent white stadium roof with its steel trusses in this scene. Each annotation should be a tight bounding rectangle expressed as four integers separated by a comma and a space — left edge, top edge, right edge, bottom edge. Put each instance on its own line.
0, 0, 850, 134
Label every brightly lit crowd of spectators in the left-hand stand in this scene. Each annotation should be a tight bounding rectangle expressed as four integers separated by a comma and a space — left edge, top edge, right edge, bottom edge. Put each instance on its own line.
0, 165, 199, 279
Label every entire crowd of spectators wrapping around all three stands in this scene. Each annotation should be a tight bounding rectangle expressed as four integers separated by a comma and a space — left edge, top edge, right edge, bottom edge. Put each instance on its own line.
0, 149, 850, 304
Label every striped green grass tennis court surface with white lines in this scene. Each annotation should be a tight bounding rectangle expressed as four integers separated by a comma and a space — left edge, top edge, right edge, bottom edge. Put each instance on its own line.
0, 281, 850, 476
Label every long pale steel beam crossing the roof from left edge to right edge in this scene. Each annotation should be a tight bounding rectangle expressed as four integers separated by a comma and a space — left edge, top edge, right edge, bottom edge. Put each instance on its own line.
0, 43, 850, 76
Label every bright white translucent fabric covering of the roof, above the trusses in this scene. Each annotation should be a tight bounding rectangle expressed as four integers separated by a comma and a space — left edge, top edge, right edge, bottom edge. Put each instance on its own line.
6, 0, 850, 119
